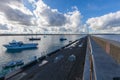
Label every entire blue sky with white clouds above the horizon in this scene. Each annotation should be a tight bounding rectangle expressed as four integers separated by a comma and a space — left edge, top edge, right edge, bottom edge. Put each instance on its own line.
0, 0, 120, 34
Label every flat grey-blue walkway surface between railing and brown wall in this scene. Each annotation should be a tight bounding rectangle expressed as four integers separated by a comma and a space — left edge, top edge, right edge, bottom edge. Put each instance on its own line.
90, 39, 120, 80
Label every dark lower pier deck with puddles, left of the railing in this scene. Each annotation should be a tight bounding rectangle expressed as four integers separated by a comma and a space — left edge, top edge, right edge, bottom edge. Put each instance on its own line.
6, 37, 87, 80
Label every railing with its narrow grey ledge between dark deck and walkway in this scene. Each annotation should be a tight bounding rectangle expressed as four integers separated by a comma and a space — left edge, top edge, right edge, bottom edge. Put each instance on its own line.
83, 36, 97, 80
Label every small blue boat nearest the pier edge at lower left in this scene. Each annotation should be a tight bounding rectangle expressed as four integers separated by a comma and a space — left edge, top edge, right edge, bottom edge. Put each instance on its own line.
3, 60, 24, 69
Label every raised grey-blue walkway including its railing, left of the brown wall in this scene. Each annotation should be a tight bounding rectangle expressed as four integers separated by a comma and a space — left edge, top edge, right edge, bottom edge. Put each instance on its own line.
83, 38, 120, 80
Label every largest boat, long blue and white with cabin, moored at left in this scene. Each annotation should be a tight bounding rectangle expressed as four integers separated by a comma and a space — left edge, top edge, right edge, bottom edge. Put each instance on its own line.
3, 40, 38, 50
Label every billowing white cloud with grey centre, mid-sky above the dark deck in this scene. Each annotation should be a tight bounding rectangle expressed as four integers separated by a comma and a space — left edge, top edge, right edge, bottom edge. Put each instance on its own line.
33, 0, 82, 33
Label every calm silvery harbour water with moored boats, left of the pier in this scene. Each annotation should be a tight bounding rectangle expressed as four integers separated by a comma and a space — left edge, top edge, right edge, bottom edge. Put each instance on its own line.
0, 35, 84, 69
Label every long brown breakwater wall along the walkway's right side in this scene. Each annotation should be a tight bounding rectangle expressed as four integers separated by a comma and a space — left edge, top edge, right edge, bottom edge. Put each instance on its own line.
92, 36, 120, 64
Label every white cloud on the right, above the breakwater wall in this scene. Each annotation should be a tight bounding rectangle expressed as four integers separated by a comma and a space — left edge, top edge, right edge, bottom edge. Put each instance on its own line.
86, 11, 120, 33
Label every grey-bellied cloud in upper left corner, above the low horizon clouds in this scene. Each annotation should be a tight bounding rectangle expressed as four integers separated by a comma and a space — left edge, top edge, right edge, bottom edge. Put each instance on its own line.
0, 0, 33, 25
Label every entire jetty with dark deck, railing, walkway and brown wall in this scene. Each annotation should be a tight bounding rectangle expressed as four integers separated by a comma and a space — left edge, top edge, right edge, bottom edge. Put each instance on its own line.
0, 35, 120, 80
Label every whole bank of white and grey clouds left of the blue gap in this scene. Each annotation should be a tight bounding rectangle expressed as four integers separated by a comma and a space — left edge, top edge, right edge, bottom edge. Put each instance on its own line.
0, 0, 83, 33
